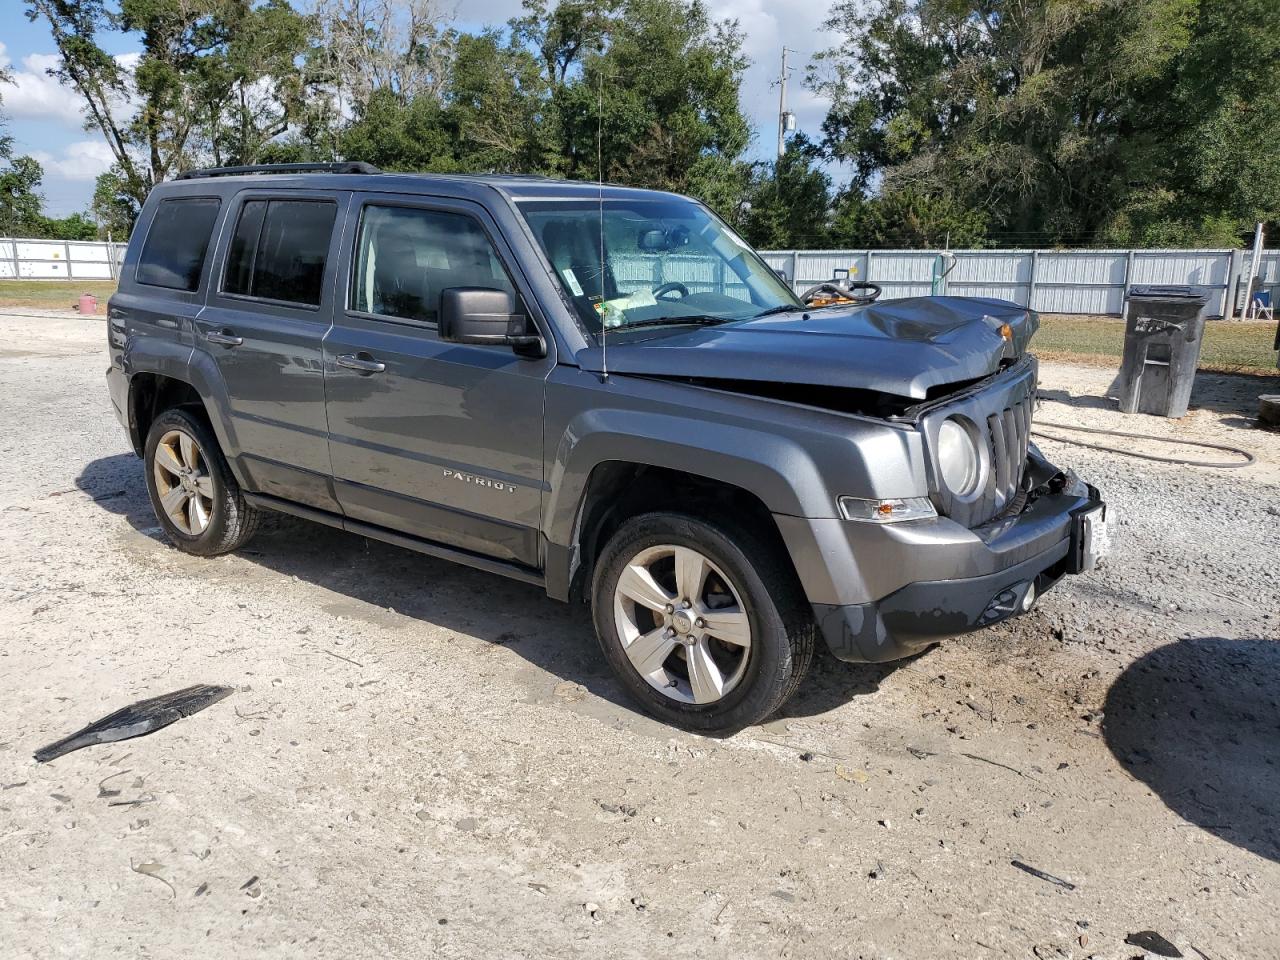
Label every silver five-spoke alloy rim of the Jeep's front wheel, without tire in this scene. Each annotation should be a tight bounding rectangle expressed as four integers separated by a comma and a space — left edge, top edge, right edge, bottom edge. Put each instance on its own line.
613, 544, 751, 704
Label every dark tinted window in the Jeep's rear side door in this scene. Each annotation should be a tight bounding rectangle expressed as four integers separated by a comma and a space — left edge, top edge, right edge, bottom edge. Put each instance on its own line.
223, 200, 338, 307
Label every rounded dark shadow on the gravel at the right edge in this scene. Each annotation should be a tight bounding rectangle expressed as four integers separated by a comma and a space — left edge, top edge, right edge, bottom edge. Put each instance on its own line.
1103, 637, 1280, 860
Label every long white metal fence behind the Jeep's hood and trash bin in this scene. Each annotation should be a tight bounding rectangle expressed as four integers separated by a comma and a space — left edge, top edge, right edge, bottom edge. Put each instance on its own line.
762, 250, 1280, 316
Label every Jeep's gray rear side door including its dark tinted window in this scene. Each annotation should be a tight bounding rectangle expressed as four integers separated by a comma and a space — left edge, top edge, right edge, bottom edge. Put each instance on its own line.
192, 189, 351, 512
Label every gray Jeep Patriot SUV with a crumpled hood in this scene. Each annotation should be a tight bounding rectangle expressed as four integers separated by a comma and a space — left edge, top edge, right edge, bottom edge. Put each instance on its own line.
108, 164, 1106, 732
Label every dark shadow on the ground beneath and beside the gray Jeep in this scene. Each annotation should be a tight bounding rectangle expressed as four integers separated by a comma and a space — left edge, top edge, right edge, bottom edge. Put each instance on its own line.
76, 454, 892, 730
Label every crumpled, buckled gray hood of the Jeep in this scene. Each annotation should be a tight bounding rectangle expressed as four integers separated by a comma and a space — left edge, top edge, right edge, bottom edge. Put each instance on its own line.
577, 297, 1039, 399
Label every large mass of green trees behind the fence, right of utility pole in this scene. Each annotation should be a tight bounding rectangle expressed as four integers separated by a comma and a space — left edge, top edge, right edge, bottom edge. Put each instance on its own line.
809, 0, 1280, 246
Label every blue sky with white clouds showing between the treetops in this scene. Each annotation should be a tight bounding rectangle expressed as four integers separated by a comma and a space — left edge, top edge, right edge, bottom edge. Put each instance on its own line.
0, 0, 828, 216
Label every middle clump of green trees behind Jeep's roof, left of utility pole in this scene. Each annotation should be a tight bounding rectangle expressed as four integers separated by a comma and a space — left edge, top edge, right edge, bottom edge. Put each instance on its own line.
338, 0, 750, 216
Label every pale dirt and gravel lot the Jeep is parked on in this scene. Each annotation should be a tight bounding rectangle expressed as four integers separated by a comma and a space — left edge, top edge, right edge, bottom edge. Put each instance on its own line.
0, 316, 1280, 960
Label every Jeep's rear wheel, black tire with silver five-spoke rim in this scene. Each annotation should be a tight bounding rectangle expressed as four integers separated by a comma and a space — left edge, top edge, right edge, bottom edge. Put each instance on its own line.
142, 408, 261, 557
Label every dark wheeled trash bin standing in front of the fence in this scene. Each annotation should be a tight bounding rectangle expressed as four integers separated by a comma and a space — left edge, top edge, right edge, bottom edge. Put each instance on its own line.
1120, 287, 1207, 417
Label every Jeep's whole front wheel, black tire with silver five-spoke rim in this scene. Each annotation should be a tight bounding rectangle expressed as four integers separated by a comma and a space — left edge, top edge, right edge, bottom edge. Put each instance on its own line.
591, 513, 815, 733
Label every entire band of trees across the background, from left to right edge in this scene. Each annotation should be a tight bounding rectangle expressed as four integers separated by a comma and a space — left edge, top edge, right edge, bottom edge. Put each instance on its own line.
12, 0, 1280, 247
